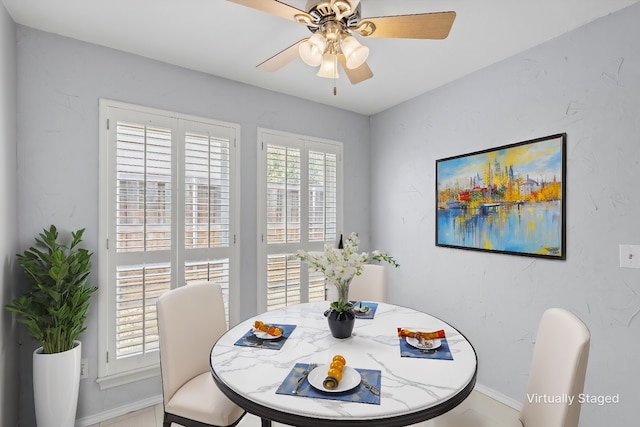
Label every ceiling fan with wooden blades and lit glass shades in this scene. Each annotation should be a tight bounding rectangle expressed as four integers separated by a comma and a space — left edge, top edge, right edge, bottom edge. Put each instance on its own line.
229, 0, 456, 86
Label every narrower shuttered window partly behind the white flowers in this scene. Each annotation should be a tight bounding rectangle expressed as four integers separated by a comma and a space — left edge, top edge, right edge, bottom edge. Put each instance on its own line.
258, 129, 342, 310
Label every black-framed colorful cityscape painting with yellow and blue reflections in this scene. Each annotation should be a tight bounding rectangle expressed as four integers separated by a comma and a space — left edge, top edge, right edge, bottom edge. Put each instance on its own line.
436, 133, 567, 260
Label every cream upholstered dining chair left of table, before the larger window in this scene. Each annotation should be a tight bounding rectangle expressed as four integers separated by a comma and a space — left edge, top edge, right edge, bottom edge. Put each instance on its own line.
157, 282, 245, 427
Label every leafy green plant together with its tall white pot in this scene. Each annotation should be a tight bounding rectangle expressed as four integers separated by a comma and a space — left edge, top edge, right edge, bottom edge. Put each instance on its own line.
5, 225, 97, 427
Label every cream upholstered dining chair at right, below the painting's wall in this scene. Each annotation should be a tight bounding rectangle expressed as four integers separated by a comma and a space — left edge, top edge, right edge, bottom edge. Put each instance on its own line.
432, 308, 591, 427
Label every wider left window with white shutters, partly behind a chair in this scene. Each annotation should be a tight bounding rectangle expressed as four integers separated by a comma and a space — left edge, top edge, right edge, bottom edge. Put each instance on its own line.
98, 100, 239, 388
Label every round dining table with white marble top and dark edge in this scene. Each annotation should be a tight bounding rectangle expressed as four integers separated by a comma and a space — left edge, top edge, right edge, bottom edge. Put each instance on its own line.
210, 301, 478, 427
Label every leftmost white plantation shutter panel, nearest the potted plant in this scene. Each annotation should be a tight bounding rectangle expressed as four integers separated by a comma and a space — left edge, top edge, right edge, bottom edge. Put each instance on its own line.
114, 121, 172, 359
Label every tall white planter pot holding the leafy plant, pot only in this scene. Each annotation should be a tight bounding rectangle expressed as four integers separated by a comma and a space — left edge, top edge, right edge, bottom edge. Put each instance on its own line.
33, 341, 82, 427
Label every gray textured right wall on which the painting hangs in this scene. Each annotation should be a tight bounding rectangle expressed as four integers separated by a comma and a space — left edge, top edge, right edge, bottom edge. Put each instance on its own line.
371, 4, 640, 427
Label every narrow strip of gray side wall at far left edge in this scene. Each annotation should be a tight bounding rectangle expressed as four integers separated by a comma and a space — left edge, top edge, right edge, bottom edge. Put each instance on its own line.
0, 2, 19, 426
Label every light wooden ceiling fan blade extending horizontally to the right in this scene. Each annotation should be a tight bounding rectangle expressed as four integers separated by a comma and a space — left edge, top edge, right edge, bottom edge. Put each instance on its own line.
353, 12, 456, 40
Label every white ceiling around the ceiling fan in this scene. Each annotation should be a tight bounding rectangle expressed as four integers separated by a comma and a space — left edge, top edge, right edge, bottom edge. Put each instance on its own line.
2, 0, 640, 115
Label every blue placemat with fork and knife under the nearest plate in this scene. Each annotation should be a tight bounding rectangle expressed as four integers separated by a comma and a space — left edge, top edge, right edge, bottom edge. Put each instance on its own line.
276, 363, 381, 405
